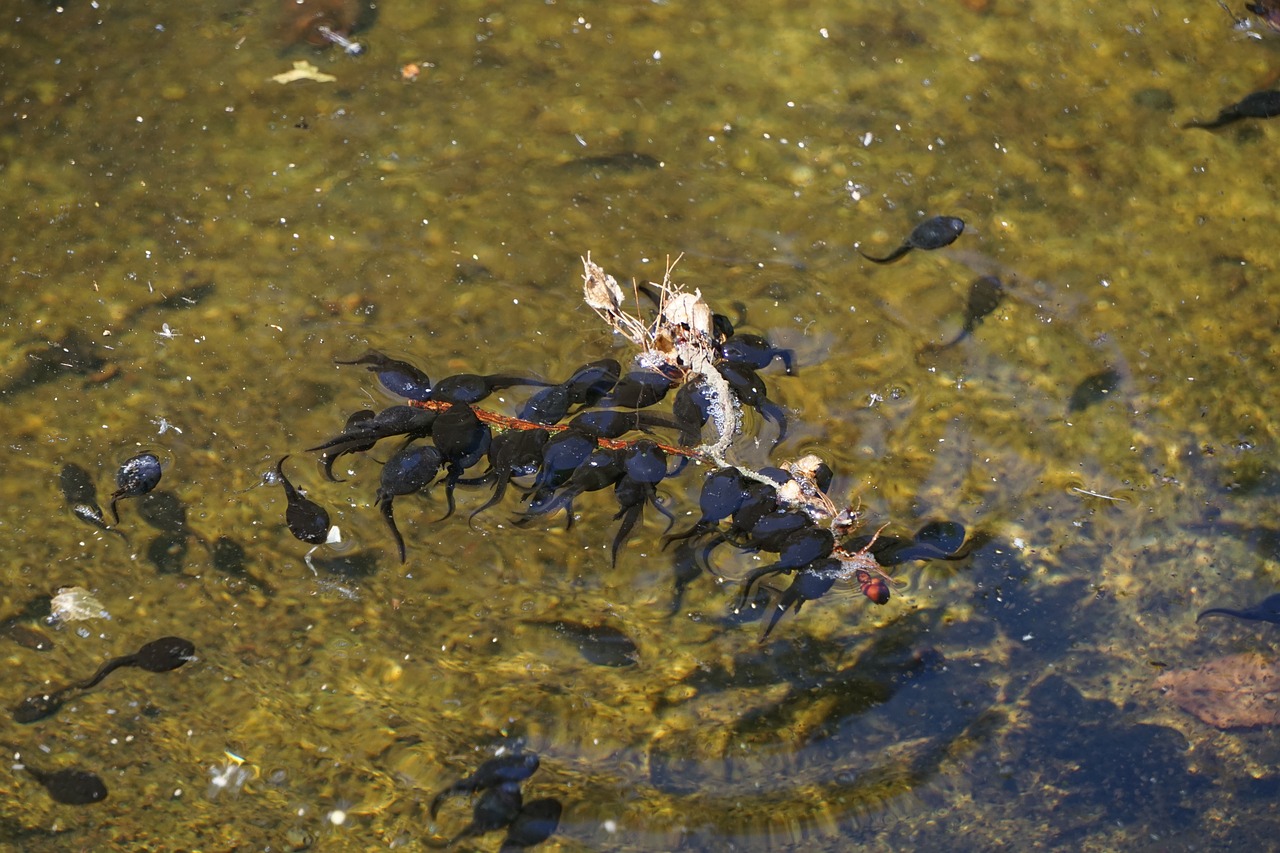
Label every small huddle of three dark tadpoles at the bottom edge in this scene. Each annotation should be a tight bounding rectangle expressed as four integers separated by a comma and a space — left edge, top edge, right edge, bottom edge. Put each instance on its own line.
428, 749, 562, 853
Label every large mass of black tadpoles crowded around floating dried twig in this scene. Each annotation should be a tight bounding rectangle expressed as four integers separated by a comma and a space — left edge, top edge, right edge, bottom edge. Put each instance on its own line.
276, 259, 967, 639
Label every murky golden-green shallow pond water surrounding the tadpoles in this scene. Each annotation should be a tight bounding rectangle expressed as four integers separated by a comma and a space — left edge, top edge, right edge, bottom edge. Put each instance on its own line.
0, 0, 1280, 850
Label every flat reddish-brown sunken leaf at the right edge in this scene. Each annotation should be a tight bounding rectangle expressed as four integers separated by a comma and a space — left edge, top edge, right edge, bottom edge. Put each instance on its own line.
1156, 653, 1280, 729
